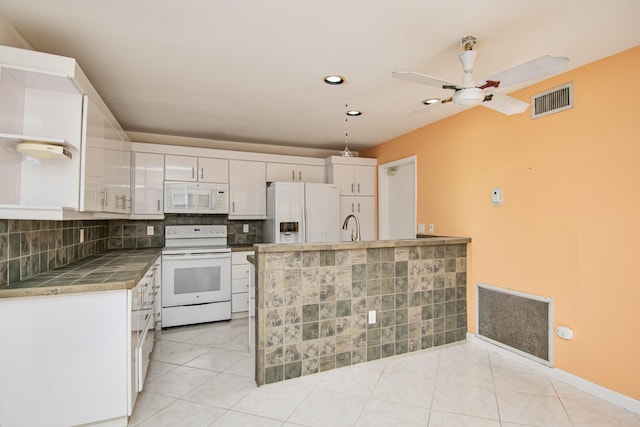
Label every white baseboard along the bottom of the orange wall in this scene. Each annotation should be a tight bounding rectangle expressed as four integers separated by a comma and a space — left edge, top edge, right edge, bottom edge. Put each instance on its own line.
467, 332, 640, 414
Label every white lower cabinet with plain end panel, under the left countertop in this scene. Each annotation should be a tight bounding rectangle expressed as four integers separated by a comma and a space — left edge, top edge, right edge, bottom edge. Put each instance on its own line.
0, 256, 159, 427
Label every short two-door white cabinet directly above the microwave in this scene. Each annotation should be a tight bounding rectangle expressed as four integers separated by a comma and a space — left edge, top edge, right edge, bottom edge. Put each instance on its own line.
164, 154, 229, 183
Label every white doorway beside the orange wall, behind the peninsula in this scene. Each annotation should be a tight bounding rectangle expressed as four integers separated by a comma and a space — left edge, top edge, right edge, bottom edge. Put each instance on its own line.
378, 156, 417, 240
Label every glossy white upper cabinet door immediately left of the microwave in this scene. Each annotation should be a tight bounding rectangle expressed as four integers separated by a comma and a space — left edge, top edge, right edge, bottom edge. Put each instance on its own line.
133, 153, 164, 215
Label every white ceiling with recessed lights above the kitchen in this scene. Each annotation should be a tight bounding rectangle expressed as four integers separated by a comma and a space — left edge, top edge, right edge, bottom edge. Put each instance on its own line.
0, 0, 640, 150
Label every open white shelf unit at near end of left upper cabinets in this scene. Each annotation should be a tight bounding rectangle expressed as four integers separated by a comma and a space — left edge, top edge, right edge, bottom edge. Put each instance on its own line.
0, 46, 84, 211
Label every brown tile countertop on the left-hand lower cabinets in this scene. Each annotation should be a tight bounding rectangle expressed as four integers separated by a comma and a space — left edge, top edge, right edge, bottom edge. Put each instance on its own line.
0, 248, 162, 298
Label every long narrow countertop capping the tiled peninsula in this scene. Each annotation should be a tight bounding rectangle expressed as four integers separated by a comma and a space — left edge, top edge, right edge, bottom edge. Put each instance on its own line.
253, 235, 471, 252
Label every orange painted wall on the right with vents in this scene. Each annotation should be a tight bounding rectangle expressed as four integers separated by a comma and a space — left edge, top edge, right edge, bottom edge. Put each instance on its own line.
360, 47, 640, 399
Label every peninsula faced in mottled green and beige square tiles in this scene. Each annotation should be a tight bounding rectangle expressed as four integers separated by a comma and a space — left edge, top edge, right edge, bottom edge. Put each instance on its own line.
253, 237, 471, 385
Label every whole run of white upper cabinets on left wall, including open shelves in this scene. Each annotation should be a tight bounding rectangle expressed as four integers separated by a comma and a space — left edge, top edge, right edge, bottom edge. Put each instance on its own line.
0, 46, 130, 219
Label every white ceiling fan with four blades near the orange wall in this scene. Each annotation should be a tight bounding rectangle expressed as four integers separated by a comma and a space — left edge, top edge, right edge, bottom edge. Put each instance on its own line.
393, 36, 569, 115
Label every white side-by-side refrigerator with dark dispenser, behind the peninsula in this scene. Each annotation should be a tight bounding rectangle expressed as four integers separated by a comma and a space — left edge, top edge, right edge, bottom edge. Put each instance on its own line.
264, 182, 340, 243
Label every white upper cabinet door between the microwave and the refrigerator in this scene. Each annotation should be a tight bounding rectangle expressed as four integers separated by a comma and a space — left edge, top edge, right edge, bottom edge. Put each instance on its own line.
229, 160, 267, 219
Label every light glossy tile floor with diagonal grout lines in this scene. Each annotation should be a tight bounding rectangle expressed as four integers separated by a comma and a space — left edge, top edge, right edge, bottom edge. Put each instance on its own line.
129, 319, 640, 427
